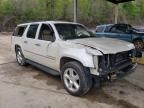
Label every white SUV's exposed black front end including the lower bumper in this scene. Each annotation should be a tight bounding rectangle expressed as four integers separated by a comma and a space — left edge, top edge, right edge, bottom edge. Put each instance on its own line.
98, 51, 137, 78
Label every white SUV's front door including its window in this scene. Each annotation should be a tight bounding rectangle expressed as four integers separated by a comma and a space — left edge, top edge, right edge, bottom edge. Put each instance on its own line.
35, 24, 57, 69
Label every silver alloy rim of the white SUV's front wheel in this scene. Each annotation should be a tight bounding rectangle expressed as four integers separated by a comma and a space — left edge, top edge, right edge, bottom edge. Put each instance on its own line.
64, 68, 80, 92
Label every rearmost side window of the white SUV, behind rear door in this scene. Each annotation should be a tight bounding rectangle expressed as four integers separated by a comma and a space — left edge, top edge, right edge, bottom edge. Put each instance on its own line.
13, 26, 27, 37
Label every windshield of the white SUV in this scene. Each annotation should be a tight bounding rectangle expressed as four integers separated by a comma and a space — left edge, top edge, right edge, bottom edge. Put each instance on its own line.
55, 24, 96, 40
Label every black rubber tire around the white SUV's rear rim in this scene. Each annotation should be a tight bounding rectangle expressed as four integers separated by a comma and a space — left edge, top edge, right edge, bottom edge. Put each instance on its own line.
16, 47, 27, 66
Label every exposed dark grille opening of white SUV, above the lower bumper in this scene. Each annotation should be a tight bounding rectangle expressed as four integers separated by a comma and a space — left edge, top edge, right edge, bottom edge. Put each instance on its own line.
98, 50, 133, 72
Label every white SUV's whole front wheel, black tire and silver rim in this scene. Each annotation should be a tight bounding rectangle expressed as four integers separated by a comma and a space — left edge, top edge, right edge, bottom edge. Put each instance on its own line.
62, 61, 92, 96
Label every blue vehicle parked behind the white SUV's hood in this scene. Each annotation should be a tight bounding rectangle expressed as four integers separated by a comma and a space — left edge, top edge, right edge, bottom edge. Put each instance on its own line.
96, 24, 144, 50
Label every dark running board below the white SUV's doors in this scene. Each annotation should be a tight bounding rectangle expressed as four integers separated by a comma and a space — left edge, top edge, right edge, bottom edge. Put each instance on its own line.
26, 59, 60, 76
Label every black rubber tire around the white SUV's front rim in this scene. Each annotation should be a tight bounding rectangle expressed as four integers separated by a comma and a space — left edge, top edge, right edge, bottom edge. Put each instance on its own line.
61, 61, 92, 96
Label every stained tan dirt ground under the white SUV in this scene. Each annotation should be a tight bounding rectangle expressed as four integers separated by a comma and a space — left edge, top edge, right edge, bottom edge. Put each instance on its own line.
0, 35, 144, 108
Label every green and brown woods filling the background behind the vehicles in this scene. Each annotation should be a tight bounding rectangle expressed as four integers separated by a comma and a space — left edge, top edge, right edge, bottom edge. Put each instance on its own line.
0, 0, 144, 29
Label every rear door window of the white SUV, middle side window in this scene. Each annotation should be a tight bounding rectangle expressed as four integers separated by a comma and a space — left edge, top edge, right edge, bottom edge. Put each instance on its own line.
27, 24, 39, 39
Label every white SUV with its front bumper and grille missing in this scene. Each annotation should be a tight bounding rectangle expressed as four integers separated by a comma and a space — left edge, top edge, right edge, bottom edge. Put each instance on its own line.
12, 21, 136, 96
